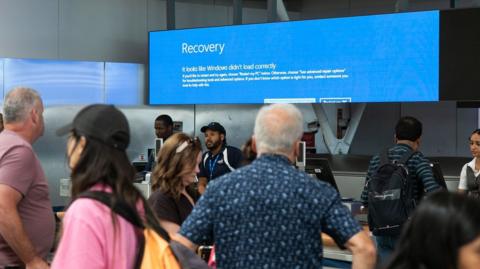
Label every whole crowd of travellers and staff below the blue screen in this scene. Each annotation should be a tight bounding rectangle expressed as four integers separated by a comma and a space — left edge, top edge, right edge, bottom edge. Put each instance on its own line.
0, 87, 480, 269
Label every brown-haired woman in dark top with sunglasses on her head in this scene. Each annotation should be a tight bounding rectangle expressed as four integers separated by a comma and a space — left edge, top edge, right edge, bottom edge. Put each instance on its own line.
148, 133, 202, 234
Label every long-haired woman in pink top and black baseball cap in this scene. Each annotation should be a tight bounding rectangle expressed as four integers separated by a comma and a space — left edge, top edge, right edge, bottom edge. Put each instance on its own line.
52, 105, 145, 269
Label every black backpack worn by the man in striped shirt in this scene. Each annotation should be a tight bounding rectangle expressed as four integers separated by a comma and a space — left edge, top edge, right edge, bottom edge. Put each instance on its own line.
367, 150, 415, 236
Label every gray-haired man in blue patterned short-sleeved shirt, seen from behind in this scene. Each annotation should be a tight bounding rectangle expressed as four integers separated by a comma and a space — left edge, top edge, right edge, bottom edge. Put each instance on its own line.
174, 104, 375, 268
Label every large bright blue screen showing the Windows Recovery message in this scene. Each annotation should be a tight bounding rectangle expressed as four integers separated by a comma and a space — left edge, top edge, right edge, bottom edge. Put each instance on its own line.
149, 11, 439, 104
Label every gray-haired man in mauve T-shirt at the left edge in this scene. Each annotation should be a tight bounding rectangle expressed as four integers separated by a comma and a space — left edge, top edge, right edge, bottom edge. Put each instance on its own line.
0, 87, 55, 269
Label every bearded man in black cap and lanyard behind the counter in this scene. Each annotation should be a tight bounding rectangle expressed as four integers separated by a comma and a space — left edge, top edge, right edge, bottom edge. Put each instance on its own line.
198, 122, 243, 193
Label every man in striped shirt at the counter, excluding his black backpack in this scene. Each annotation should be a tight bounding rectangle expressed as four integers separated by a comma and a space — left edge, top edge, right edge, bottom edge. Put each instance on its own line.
361, 116, 441, 262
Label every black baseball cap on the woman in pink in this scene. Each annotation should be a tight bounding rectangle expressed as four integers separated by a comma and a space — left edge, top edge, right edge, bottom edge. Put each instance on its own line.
56, 104, 130, 150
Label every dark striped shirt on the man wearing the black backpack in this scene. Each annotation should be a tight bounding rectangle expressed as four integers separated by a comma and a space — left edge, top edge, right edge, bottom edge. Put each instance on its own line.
361, 144, 441, 206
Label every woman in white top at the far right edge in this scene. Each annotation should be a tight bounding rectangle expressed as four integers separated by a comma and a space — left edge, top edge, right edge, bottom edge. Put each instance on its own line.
458, 129, 480, 197
